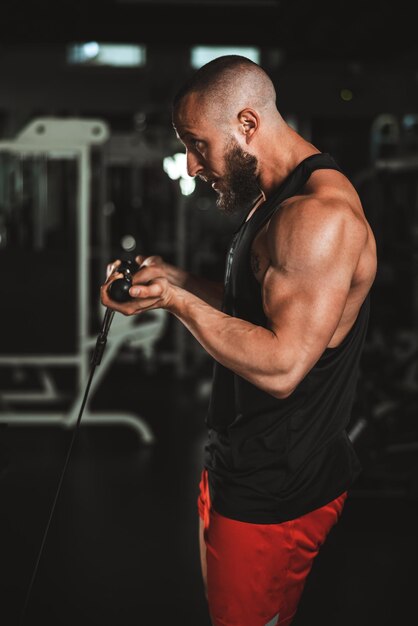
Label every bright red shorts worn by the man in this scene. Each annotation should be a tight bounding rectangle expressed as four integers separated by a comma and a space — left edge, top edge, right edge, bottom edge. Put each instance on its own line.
198, 470, 347, 626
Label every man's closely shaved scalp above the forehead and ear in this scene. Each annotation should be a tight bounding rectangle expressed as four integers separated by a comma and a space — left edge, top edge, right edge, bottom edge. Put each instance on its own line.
173, 55, 277, 122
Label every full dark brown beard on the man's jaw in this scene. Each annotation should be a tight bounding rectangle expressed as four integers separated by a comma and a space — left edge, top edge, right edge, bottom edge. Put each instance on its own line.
215, 139, 260, 215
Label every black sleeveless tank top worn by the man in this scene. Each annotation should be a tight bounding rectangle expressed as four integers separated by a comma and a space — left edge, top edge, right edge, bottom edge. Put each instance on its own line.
204, 153, 370, 524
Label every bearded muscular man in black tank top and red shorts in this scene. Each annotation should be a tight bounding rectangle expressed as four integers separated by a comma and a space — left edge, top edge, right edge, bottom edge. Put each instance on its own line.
101, 56, 376, 626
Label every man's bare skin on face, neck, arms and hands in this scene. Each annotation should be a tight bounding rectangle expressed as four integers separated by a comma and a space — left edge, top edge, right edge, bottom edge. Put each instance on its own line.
101, 92, 376, 398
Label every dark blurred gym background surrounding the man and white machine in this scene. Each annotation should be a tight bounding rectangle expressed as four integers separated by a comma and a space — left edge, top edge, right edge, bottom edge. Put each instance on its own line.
0, 0, 418, 626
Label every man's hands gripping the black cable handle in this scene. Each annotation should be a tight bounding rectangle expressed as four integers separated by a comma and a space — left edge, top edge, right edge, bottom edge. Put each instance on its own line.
100, 255, 174, 315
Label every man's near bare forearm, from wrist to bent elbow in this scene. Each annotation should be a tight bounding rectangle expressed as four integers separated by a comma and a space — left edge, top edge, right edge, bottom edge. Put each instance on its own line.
168, 289, 292, 397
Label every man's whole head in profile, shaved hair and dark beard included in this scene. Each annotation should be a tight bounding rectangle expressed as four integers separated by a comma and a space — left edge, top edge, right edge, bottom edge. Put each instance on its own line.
172, 55, 281, 213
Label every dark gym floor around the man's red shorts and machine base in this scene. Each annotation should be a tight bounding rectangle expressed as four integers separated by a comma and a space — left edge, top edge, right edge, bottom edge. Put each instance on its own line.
0, 356, 418, 626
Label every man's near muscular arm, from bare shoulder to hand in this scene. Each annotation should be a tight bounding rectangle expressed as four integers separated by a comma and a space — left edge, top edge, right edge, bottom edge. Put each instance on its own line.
103, 201, 365, 398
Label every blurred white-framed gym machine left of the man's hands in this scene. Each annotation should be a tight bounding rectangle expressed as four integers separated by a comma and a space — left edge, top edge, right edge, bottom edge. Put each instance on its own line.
0, 117, 170, 443
